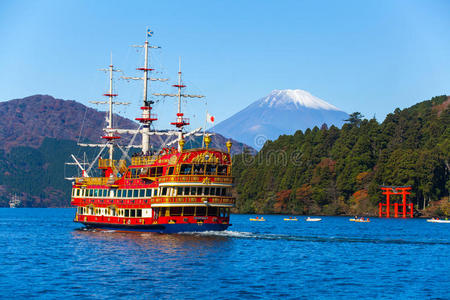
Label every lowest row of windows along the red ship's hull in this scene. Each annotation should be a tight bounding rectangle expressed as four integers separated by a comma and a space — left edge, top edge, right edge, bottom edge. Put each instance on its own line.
77, 206, 230, 218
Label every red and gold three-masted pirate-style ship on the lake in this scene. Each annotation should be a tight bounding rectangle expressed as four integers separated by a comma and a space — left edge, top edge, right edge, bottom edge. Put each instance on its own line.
71, 31, 235, 233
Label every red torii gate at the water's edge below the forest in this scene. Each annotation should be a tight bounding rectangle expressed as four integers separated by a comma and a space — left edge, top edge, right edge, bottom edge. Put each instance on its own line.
378, 186, 414, 218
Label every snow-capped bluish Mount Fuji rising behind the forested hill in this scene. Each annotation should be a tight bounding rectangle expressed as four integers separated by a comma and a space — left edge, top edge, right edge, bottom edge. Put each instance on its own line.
210, 90, 348, 150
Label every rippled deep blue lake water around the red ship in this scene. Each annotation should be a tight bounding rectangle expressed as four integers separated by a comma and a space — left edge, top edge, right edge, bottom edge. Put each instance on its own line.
0, 208, 450, 299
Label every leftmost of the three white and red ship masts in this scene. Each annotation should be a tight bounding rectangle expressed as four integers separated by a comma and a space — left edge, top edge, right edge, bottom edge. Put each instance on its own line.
89, 55, 130, 161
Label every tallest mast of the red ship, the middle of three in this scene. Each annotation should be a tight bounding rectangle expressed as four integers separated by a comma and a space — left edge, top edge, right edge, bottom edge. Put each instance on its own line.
122, 29, 167, 154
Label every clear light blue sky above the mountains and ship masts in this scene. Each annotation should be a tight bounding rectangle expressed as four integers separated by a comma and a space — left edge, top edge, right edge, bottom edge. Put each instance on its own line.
0, 0, 450, 128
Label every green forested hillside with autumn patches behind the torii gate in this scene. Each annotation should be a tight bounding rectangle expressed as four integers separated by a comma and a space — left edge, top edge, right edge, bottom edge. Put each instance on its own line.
234, 96, 450, 215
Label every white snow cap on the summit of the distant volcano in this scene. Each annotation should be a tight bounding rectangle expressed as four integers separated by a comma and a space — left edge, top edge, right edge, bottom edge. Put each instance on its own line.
259, 90, 341, 111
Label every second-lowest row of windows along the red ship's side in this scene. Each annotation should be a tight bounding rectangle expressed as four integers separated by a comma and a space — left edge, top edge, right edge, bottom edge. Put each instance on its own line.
72, 186, 231, 198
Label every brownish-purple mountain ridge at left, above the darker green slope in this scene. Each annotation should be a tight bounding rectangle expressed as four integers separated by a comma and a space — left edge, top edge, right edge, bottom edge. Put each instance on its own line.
0, 95, 137, 149
